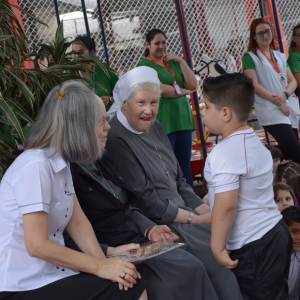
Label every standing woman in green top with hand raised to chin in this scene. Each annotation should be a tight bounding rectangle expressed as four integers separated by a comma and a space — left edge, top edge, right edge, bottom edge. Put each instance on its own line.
137, 29, 197, 187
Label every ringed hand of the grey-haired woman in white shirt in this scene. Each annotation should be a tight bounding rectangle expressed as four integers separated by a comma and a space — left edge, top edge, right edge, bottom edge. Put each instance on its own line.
95, 257, 142, 291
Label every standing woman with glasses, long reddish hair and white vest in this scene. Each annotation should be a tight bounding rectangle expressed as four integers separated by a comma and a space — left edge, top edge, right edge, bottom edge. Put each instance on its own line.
241, 18, 300, 164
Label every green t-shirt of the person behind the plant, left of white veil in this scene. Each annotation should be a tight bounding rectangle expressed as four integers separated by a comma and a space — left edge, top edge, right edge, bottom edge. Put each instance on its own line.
86, 66, 119, 111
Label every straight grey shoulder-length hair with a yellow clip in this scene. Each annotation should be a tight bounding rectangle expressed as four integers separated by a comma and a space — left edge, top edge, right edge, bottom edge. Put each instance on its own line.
24, 80, 103, 163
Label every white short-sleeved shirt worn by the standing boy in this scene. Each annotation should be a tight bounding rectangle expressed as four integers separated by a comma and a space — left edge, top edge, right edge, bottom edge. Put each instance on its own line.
204, 128, 282, 250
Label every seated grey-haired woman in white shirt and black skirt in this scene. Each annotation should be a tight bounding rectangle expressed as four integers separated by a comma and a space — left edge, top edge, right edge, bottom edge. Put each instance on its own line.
0, 81, 147, 300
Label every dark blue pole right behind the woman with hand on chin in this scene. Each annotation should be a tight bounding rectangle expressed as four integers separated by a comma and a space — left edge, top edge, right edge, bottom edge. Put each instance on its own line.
174, 0, 207, 158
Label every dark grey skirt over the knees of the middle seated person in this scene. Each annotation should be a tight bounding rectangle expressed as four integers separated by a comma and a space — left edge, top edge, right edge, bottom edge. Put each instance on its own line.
137, 249, 218, 300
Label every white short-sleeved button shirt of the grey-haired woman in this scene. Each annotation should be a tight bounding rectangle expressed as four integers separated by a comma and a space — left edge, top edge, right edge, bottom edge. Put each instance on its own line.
0, 150, 78, 292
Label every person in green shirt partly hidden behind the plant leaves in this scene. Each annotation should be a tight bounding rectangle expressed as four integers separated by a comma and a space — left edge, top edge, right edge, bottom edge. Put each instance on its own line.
72, 36, 119, 111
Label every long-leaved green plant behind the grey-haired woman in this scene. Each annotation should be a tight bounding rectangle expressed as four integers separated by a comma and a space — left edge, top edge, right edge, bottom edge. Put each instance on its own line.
0, 0, 114, 181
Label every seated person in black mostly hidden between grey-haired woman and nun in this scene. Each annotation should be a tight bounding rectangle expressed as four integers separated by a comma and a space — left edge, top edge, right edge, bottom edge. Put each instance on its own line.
68, 102, 218, 300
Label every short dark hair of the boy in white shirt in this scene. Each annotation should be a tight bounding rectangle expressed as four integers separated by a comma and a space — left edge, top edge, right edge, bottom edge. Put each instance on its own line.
203, 73, 255, 122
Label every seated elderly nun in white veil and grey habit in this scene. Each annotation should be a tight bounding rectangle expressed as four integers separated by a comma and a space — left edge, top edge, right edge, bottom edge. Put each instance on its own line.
102, 67, 242, 300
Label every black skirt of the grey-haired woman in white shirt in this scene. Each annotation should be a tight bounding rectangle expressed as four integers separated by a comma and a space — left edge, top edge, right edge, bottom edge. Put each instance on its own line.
0, 273, 146, 300
